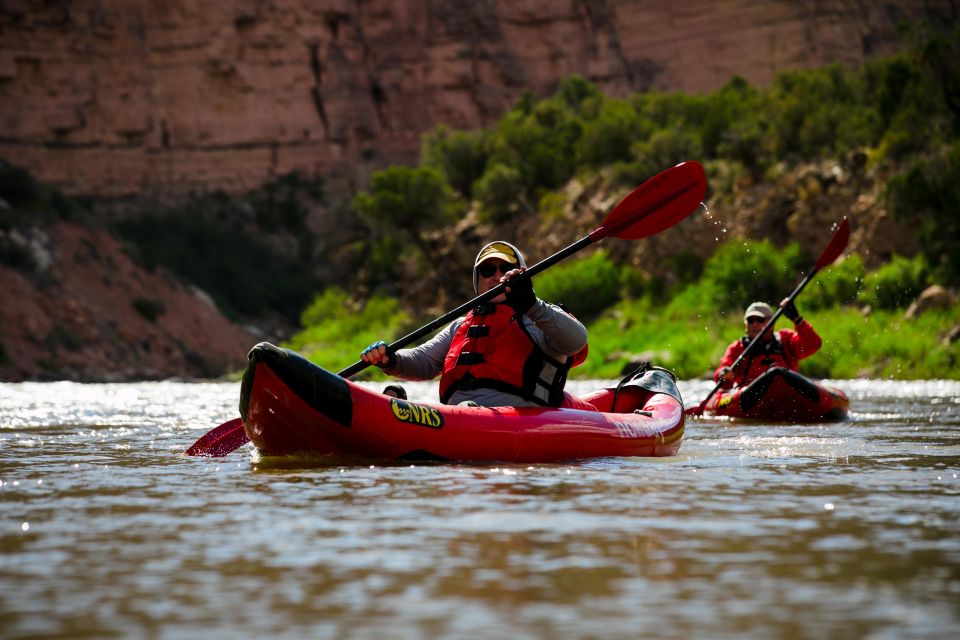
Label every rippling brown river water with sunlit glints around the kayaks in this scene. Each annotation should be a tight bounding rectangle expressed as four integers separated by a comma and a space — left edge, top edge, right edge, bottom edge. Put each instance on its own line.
0, 380, 960, 640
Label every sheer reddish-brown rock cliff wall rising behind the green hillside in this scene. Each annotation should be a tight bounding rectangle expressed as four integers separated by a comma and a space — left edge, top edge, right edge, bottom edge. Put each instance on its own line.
0, 0, 960, 196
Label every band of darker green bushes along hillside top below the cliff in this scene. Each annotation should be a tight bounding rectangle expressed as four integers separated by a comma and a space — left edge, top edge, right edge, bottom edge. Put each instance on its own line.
356, 21, 960, 290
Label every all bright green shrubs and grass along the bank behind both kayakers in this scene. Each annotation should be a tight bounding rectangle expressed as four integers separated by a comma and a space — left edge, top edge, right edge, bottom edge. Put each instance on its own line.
288, 240, 960, 379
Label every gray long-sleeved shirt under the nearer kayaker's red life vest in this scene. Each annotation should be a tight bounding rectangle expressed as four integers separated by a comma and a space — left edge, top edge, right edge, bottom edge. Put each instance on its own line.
383, 299, 587, 407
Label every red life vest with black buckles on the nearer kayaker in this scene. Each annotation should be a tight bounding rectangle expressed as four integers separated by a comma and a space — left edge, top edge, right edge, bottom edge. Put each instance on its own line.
440, 304, 587, 407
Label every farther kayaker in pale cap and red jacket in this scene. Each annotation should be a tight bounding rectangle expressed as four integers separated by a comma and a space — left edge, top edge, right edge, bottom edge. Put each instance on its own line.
713, 298, 823, 389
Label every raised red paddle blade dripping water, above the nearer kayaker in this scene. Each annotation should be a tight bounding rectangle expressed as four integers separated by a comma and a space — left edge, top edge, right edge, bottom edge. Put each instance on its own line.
590, 160, 707, 242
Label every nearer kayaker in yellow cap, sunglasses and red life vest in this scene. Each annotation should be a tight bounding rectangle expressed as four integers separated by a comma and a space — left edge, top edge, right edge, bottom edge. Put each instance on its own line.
360, 241, 596, 411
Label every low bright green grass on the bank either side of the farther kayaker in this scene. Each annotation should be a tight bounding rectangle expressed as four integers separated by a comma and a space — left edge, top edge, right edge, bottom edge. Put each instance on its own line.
574, 298, 960, 380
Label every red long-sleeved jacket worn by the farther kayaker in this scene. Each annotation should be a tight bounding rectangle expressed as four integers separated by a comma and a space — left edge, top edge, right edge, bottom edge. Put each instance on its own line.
713, 320, 823, 387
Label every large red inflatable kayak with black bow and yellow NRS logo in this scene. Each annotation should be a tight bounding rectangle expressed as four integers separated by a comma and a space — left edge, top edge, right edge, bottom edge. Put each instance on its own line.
240, 343, 684, 462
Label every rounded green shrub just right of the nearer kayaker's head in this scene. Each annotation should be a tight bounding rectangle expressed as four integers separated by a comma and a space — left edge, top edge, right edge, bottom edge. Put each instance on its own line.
534, 249, 620, 318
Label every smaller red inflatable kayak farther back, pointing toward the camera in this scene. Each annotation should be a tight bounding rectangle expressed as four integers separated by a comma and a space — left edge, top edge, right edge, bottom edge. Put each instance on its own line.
704, 367, 850, 422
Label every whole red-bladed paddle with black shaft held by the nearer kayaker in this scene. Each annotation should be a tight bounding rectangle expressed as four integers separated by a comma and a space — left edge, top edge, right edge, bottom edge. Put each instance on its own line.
185, 161, 707, 458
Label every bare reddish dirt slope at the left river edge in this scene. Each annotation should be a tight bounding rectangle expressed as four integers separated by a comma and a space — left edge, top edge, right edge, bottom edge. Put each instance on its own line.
0, 222, 257, 381
